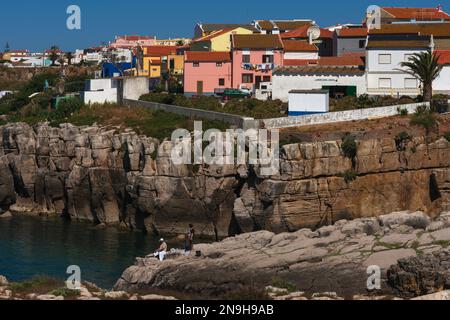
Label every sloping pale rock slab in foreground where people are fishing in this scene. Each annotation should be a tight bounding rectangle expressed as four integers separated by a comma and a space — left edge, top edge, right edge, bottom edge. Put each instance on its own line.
115, 212, 450, 298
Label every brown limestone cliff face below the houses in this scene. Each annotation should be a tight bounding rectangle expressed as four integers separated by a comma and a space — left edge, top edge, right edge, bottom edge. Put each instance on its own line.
0, 123, 450, 237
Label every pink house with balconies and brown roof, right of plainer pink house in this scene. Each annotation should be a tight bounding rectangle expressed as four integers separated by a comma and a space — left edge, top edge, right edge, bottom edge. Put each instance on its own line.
232, 34, 284, 91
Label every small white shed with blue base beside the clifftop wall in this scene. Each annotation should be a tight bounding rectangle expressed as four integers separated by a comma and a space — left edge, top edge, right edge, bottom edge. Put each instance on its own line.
289, 90, 330, 116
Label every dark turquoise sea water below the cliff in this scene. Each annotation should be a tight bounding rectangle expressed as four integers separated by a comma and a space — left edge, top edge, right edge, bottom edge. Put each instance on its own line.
0, 216, 171, 289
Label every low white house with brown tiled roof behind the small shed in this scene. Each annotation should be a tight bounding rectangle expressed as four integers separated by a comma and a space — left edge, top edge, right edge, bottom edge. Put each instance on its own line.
272, 56, 366, 102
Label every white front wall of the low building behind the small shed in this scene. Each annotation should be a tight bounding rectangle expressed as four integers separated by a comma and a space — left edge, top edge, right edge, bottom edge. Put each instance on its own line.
272, 74, 366, 102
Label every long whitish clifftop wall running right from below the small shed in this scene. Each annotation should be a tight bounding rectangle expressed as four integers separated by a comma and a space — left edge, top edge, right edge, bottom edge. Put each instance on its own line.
260, 103, 427, 129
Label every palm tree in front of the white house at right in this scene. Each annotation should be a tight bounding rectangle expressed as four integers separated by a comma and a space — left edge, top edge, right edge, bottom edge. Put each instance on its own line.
401, 50, 443, 102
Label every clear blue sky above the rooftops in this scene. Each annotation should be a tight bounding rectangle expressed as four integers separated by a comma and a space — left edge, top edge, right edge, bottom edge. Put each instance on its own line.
0, 0, 450, 51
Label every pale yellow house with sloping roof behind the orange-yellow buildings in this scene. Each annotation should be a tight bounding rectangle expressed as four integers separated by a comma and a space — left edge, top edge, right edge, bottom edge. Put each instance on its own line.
191, 27, 253, 52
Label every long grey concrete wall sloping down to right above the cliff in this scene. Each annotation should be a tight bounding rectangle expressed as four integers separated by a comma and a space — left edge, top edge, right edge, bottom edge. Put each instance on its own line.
123, 99, 258, 129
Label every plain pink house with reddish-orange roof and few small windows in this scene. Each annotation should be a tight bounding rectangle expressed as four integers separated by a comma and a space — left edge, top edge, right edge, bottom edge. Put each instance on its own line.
184, 51, 232, 96
